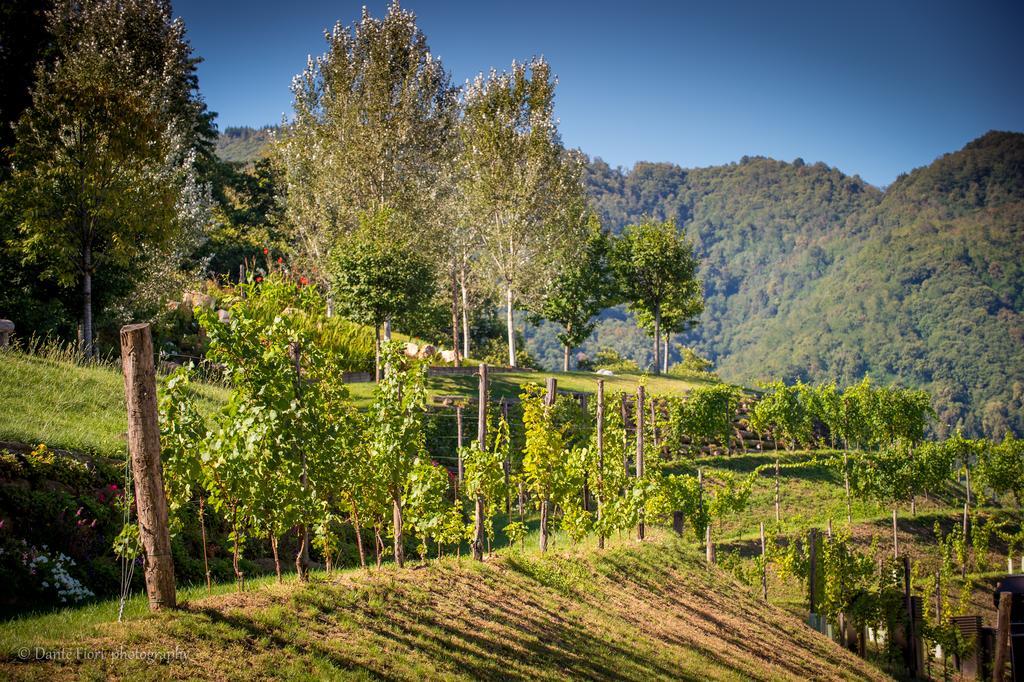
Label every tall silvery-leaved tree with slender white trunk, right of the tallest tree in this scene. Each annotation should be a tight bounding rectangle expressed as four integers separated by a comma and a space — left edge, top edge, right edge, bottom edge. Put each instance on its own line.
458, 58, 587, 367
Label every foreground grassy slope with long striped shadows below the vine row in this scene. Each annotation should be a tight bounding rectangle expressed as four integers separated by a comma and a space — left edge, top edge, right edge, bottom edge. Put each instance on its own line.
0, 538, 883, 680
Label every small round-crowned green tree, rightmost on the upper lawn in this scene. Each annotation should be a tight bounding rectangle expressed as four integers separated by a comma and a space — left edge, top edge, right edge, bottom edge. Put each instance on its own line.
612, 219, 703, 374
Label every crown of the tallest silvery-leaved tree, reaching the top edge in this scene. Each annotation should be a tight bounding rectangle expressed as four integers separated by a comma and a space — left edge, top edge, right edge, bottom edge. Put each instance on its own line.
274, 2, 458, 276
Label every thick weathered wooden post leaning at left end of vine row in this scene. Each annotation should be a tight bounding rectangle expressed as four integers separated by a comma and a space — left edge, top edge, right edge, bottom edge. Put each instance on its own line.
121, 324, 177, 611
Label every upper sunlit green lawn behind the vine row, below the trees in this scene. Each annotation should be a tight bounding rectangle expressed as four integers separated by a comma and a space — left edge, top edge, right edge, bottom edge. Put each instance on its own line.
0, 352, 693, 456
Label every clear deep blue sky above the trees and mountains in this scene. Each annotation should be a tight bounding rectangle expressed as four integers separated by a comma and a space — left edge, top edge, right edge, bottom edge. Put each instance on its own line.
174, 0, 1024, 185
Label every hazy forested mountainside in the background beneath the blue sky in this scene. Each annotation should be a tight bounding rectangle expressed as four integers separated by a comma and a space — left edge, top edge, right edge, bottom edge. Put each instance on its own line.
219, 130, 1024, 436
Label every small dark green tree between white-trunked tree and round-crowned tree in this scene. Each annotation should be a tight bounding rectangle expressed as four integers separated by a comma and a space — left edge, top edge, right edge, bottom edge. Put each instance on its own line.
532, 215, 618, 372
